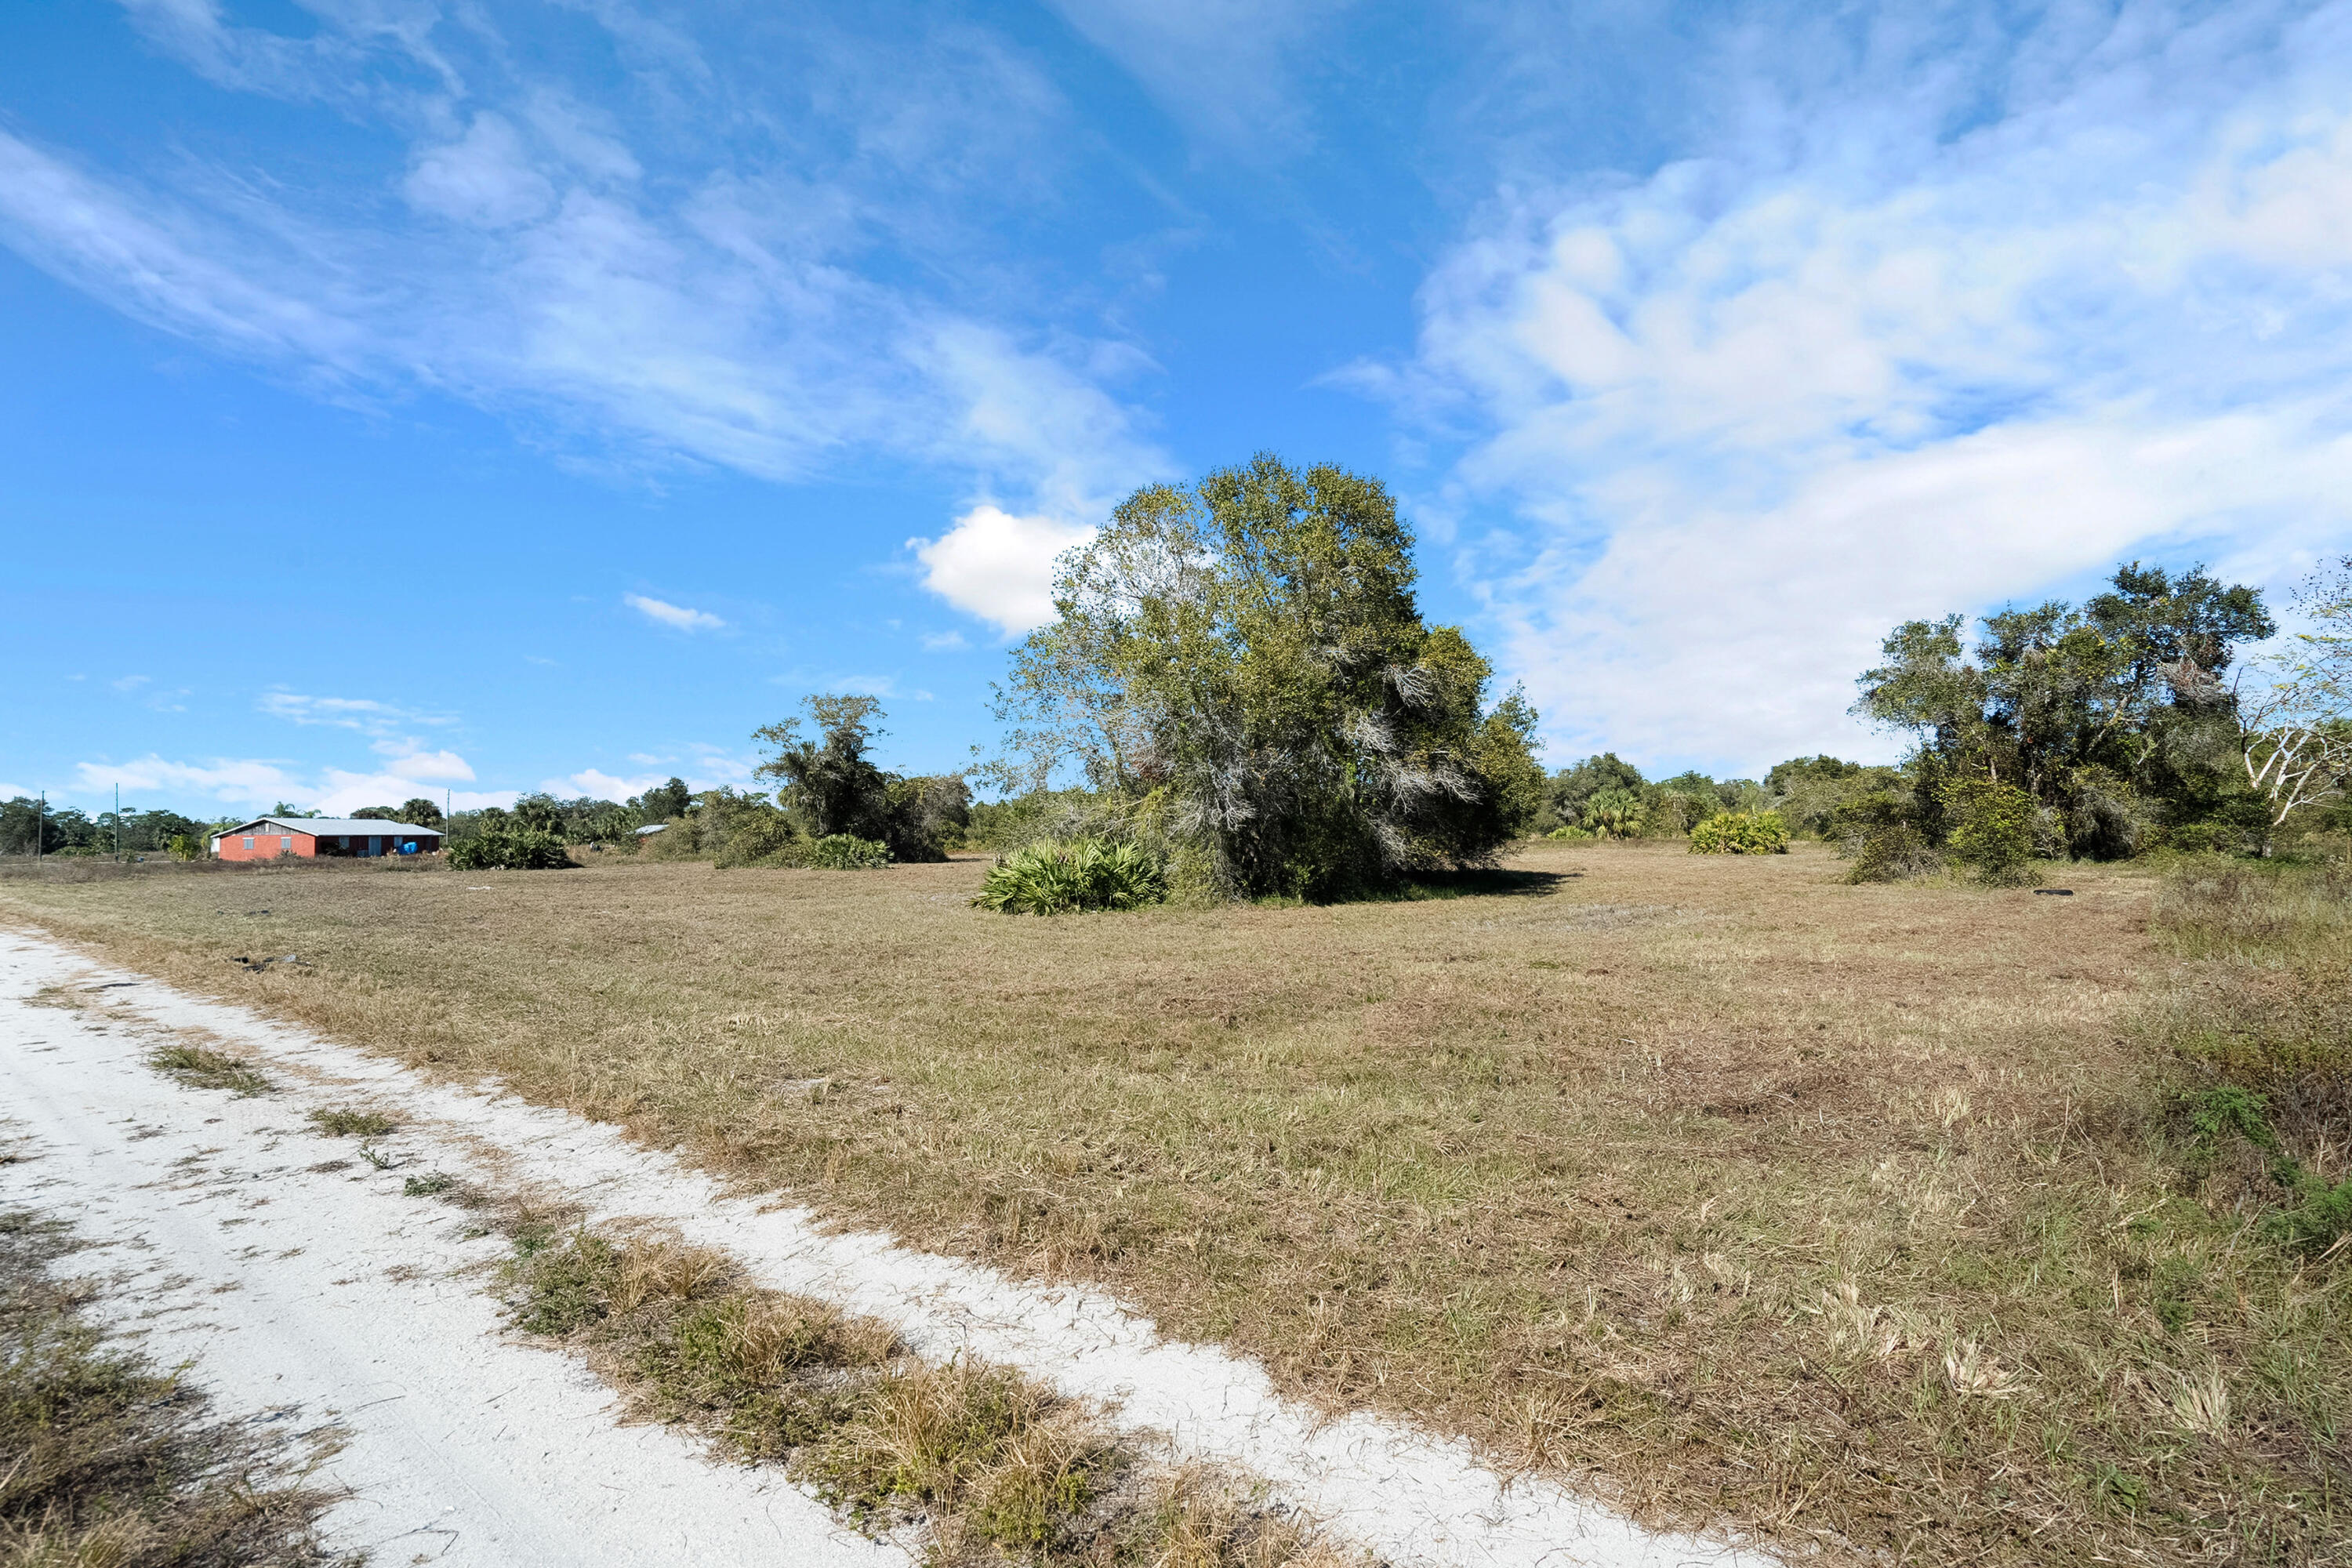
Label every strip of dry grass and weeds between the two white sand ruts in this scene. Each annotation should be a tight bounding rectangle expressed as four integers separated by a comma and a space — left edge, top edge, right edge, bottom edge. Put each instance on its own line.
508, 1229, 1343, 1568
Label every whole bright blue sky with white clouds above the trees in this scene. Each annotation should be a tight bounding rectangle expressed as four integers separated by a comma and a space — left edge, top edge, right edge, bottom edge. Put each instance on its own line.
0, 0, 2352, 815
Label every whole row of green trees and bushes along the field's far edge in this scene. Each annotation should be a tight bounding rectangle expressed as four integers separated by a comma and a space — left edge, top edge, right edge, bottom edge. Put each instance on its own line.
0, 454, 2352, 888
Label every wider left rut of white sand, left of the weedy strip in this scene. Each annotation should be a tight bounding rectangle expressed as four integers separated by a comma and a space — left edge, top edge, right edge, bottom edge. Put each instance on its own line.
0, 931, 910, 1568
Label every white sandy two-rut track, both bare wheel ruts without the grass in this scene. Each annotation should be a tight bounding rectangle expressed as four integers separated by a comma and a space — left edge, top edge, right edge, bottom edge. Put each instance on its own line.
0, 931, 1776, 1568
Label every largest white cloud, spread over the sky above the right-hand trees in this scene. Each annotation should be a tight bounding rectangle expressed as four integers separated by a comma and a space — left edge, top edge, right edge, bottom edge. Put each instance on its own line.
1364, 5, 2352, 767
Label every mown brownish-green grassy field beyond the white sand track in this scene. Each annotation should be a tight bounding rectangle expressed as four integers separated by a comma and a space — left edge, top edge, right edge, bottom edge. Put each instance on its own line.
0, 844, 2352, 1563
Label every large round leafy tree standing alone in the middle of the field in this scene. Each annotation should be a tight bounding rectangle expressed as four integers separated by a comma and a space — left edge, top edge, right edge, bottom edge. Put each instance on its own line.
1000, 454, 1543, 895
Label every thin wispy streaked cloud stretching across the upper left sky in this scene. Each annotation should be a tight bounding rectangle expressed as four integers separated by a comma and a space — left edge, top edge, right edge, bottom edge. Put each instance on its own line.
0, 0, 1160, 515
